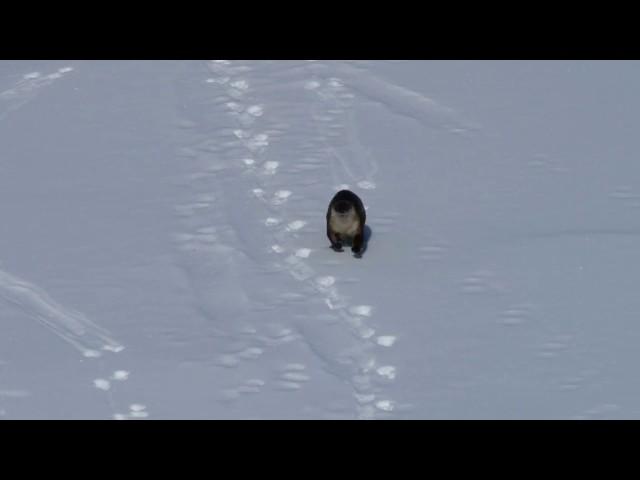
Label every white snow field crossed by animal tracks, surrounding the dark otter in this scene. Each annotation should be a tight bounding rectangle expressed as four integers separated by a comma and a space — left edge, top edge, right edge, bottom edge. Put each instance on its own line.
0, 60, 640, 419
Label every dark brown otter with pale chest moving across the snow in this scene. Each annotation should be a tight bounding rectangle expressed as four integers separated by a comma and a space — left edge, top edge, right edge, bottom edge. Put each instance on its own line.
327, 190, 367, 255
